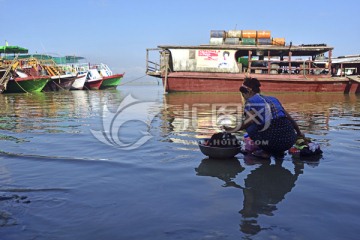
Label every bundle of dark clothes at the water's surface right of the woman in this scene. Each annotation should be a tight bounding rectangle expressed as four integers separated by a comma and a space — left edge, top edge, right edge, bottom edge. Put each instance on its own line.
289, 138, 323, 157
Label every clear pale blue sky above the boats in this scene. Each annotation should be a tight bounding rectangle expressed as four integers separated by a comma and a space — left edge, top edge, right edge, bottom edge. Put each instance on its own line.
0, 0, 360, 81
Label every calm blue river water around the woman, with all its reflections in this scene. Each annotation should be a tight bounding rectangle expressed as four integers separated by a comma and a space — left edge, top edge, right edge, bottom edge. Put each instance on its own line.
0, 85, 360, 240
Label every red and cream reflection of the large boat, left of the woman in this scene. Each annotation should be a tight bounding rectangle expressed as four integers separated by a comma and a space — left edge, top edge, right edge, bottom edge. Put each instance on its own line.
163, 93, 242, 141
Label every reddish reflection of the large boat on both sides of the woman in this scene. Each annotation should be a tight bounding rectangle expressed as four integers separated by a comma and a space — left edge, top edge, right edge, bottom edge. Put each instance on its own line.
162, 93, 360, 142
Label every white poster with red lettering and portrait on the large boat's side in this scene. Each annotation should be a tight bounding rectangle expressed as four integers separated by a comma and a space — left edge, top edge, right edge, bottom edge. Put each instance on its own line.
196, 49, 234, 68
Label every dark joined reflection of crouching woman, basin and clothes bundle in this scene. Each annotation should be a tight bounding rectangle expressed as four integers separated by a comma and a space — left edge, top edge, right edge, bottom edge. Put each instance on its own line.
195, 155, 319, 235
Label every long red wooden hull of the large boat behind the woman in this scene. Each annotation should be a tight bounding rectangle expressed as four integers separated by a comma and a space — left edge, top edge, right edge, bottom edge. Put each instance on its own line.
162, 72, 360, 93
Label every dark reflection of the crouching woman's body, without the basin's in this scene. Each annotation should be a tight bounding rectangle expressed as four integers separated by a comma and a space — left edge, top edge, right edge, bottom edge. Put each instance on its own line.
239, 158, 304, 234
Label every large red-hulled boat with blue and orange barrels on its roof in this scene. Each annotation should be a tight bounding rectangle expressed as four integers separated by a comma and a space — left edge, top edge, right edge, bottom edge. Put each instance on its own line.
146, 30, 360, 93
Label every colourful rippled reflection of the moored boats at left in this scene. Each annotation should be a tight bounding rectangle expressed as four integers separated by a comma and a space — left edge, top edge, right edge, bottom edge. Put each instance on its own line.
0, 89, 124, 134
